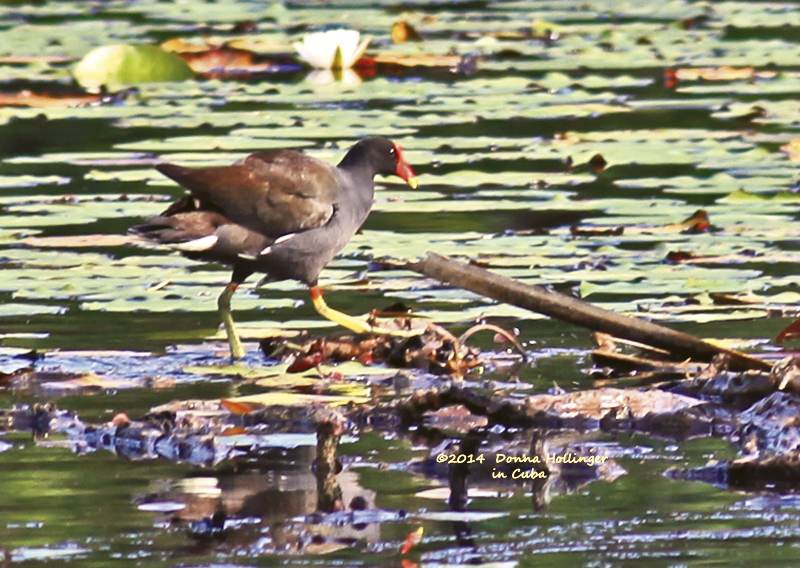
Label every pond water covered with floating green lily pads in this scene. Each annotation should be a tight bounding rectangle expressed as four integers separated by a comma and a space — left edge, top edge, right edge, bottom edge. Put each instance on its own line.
0, 0, 800, 568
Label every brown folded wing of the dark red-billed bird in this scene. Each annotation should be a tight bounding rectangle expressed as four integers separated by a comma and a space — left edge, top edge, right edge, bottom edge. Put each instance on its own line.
157, 150, 340, 238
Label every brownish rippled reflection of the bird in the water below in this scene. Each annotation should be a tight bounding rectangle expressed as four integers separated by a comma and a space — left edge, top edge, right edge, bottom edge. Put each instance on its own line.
137, 446, 380, 554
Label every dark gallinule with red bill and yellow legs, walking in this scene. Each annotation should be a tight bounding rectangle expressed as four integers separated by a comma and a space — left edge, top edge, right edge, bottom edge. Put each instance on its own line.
131, 138, 417, 359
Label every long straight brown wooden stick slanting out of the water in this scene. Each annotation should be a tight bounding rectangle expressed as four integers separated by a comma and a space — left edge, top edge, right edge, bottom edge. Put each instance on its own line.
408, 253, 772, 371
